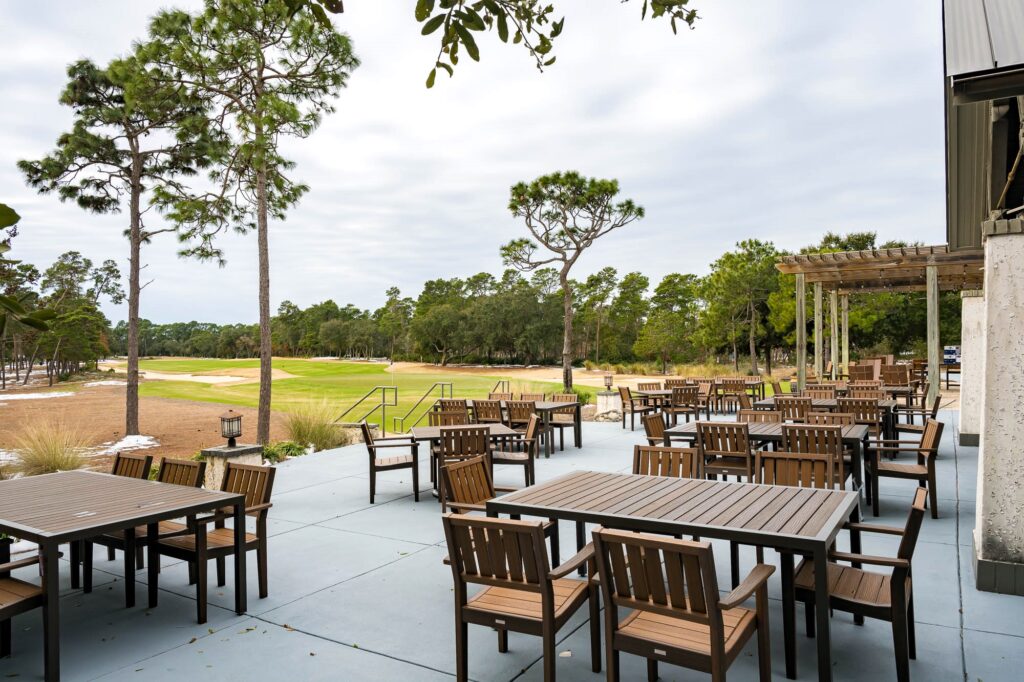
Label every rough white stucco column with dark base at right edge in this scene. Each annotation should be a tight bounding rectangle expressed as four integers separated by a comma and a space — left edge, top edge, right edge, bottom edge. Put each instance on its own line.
974, 219, 1024, 595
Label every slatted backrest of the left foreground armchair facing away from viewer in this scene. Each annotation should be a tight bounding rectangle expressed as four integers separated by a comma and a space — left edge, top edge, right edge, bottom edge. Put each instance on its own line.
442, 514, 552, 593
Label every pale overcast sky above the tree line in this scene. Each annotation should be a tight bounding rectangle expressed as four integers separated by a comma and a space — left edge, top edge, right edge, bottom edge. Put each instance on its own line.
0, 0, 945, 323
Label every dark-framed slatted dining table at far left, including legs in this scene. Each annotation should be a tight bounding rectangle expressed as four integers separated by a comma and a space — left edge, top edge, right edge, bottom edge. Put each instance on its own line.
0, 471, 247, 681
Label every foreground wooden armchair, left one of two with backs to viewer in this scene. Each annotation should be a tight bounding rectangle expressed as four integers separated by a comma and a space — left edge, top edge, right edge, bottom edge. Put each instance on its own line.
442, 514, 601, 682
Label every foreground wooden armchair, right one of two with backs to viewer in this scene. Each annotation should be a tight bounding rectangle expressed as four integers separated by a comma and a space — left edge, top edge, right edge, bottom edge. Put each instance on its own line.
594, 528, 775, 682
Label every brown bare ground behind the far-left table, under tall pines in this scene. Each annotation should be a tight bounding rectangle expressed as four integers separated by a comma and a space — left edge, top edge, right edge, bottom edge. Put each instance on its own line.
0, 386, 287, 466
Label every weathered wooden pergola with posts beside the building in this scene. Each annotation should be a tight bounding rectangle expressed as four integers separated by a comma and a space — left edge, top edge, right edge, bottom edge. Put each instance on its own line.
776, 245, 985, 401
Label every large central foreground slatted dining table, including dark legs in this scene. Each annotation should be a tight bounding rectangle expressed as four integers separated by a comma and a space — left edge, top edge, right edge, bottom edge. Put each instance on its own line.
486, 471, 860, 680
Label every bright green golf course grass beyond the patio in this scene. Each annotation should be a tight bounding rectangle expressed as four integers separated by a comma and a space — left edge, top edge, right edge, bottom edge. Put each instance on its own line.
139, 358, 560, 430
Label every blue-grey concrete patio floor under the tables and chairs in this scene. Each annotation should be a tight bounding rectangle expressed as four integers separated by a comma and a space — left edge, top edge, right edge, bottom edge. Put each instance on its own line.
0, 411, 1024, 682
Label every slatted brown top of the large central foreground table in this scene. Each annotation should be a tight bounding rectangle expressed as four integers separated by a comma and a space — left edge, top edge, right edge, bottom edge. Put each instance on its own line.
487, 471, 858, 546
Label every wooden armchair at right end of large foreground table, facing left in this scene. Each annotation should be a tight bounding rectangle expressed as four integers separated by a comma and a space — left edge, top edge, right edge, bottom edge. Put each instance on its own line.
791, 487, 928, 682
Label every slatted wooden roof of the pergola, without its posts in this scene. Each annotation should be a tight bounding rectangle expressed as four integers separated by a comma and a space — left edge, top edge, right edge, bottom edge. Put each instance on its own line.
775, 246, 985, 293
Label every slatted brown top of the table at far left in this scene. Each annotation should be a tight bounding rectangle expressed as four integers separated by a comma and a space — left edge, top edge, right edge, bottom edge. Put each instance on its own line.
0, 471, 244, 540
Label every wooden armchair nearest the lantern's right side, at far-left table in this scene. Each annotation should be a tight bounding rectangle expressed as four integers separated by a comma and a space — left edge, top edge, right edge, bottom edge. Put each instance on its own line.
157, 462, 276, 624
